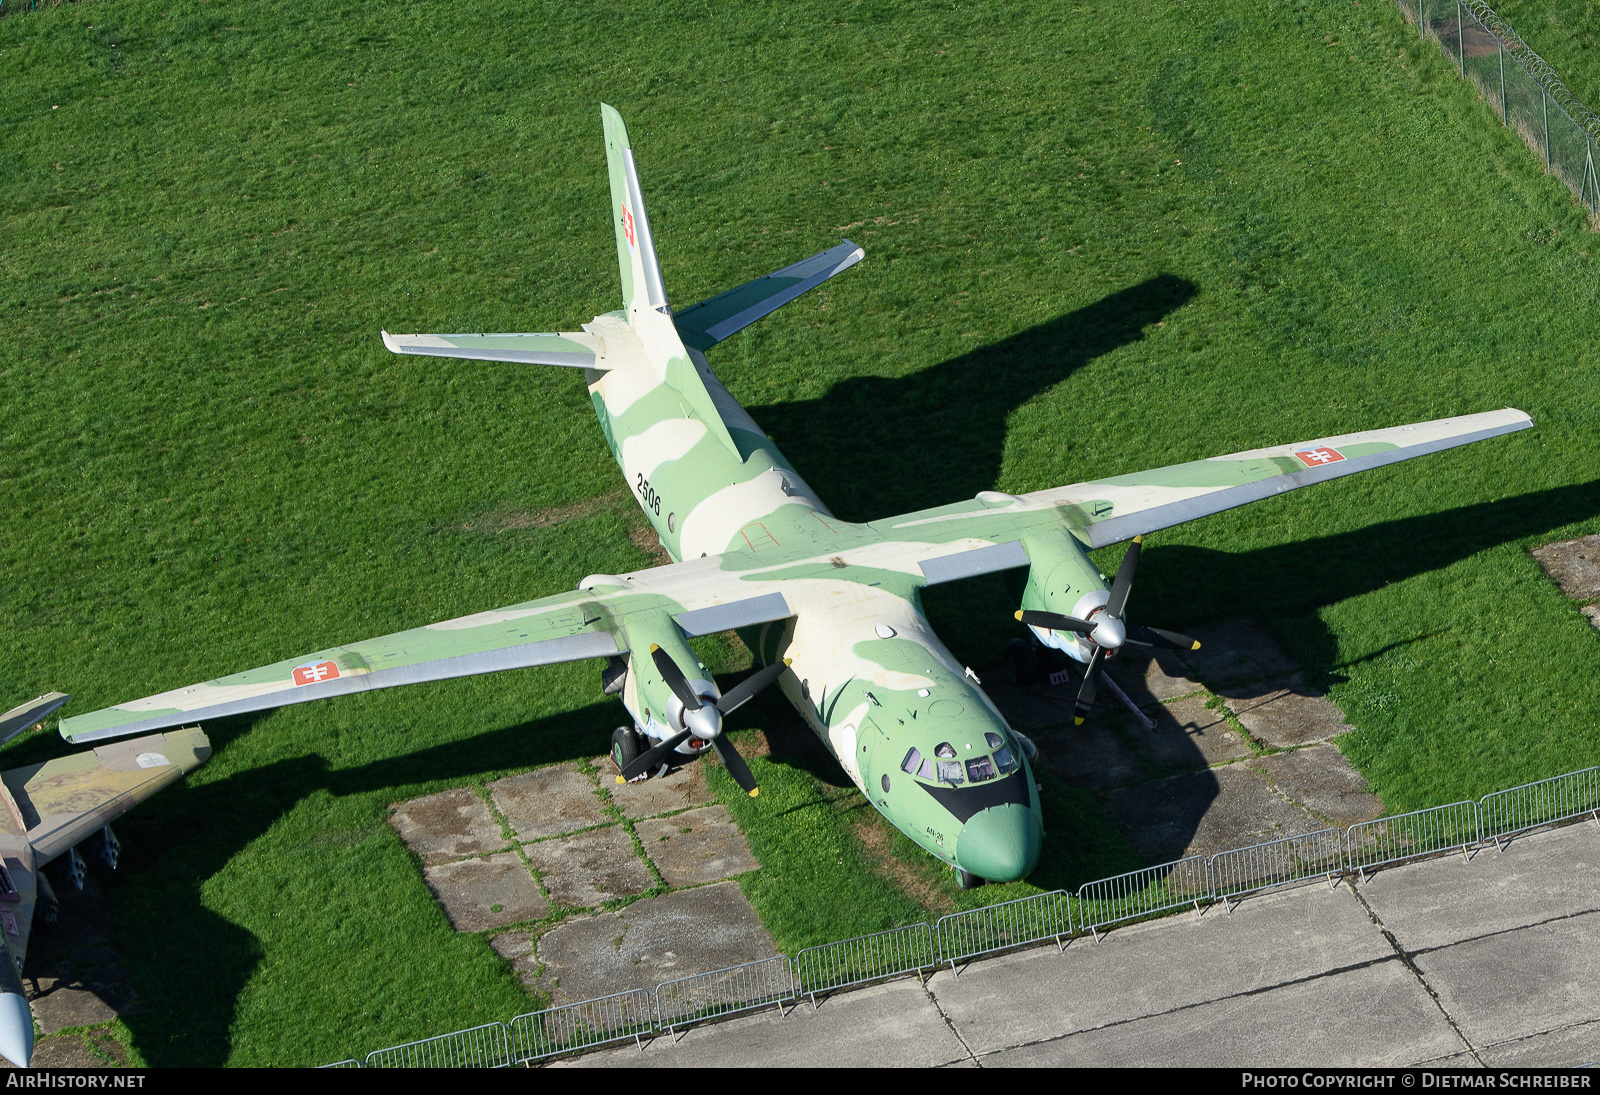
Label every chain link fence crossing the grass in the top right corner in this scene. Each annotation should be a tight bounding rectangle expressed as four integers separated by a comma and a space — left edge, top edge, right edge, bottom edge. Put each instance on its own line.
1397, 0, 1600, 227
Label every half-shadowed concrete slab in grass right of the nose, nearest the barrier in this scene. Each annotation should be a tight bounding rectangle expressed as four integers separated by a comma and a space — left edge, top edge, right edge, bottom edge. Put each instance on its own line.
1101, 764, 1325, 863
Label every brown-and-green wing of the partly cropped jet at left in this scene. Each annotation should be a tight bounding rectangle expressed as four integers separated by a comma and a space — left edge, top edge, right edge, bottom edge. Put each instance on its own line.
0, 727, 211, 866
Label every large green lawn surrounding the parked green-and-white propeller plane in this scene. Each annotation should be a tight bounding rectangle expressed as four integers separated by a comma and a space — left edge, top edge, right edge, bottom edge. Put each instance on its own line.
0, 0, 1600, 1065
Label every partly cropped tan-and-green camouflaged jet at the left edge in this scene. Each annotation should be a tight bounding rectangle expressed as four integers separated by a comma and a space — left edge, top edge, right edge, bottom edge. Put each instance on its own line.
0, 692, 211, 1068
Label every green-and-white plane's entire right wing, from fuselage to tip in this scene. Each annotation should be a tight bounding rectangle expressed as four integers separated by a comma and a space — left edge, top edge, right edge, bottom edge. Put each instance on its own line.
872, 407, 1533, 584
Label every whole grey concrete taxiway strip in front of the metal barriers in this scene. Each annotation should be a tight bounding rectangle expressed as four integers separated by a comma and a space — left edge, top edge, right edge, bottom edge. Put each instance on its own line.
557, 821, 1600, 1068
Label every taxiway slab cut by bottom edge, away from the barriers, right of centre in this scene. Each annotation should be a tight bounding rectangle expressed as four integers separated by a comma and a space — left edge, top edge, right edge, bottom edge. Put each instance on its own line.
982, 961, 1466, 1068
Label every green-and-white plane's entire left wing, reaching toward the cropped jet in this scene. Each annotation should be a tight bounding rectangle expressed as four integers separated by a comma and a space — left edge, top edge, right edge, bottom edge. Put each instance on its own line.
61, 559, 792, 741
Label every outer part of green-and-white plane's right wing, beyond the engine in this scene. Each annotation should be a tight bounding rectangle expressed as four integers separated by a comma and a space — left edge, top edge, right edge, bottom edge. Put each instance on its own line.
1027, 407, 1533, 548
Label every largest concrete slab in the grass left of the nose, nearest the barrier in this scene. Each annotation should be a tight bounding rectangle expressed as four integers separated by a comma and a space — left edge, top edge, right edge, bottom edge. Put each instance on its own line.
539, 882, 778, 1004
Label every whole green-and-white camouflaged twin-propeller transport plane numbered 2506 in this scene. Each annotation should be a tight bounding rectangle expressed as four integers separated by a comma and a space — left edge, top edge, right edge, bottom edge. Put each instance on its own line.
61, 106, 1533, 885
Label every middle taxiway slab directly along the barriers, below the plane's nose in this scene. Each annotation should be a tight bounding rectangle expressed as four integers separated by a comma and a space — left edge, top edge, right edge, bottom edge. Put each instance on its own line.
928, 885, 1388, 1053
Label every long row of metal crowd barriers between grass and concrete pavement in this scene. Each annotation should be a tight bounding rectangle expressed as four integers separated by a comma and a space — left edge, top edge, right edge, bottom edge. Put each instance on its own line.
339, 768, 1600, 1068
